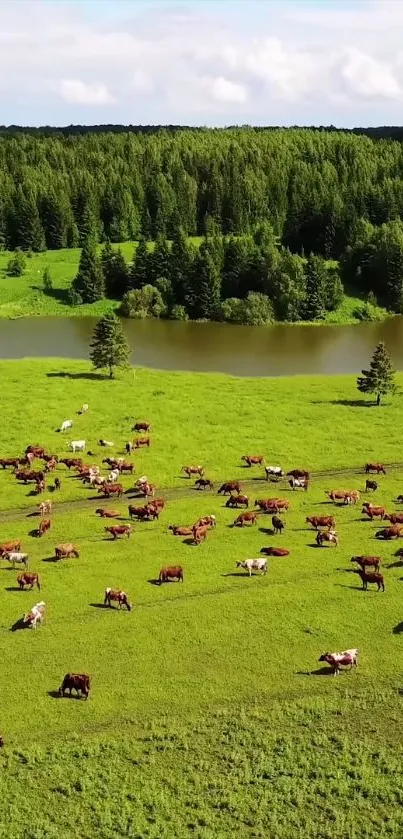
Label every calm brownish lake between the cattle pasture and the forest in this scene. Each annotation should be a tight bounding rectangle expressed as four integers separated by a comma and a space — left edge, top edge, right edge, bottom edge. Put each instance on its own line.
0, 316, 403, 376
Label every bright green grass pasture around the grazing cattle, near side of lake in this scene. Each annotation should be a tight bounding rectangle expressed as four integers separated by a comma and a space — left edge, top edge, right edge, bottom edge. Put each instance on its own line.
0, 360, 403, 839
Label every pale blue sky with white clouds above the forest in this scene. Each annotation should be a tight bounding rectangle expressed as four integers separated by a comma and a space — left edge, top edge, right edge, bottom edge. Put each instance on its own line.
0, 0, 403, 127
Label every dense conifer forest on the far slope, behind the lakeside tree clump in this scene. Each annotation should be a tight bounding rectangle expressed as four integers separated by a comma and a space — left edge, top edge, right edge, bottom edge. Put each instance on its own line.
0, 127, 403, 312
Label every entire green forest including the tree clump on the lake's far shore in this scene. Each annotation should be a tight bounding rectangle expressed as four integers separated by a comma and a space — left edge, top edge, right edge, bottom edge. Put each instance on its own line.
0, 127, 403, 322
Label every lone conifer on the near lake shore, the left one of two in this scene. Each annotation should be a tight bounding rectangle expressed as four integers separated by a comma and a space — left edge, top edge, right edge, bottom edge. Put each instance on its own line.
90, 312, 130, 379
